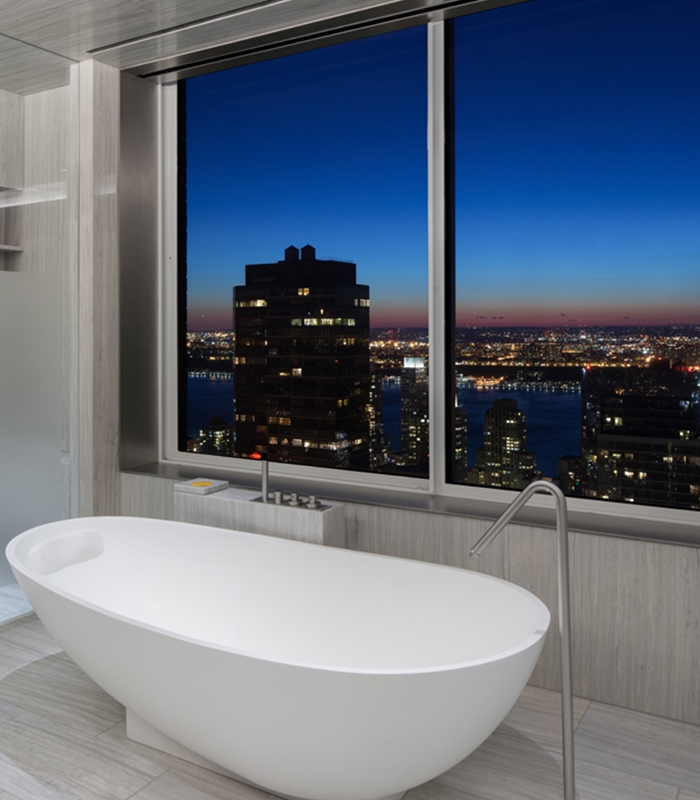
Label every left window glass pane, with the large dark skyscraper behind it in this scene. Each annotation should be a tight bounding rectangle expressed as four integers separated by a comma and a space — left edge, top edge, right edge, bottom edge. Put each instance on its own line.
180, 28, 428, 475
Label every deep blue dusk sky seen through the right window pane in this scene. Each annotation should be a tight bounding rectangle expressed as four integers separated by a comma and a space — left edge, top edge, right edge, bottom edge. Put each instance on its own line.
455, 0, 700, 325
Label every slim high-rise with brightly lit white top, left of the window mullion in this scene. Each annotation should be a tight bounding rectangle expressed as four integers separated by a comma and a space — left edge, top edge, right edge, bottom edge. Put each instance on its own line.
401, 356, 430, 474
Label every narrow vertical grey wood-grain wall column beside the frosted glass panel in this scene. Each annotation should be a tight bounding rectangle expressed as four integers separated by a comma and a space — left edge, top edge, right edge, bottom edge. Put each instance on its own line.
80, 61, 120, 515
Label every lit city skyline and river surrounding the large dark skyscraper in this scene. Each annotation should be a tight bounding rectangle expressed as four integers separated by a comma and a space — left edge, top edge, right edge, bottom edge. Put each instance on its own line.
188, 318, 700, 508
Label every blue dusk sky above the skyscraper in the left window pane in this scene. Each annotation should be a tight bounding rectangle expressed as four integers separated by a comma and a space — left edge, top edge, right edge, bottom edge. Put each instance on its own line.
187, 28, 428, 329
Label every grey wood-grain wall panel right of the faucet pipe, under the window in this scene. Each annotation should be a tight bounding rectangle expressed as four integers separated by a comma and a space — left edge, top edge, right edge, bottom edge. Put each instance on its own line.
571, 535, 700, 725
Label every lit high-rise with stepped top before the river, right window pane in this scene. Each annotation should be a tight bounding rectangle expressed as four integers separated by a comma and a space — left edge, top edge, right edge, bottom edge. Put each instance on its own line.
467, 400, 537, 489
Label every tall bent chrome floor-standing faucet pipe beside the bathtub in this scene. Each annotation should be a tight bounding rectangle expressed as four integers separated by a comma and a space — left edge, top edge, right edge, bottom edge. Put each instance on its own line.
469, 481, 576, 800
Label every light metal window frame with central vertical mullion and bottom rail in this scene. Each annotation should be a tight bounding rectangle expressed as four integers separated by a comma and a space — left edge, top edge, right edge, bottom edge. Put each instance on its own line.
158, 14, 700, 536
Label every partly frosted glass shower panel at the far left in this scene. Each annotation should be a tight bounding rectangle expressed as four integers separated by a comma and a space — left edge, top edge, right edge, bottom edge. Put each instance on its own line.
0, 36, 79, 586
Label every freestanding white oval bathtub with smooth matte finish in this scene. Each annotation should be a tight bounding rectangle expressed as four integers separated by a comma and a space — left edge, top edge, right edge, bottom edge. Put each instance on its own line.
7, 517, 550, 800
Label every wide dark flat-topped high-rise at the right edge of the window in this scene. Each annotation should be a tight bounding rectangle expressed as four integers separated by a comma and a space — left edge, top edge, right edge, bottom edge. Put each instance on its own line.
582, 361, 700, 509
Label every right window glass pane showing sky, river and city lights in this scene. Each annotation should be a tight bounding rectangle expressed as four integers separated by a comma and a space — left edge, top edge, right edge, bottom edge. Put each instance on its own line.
455, 0, 700, 508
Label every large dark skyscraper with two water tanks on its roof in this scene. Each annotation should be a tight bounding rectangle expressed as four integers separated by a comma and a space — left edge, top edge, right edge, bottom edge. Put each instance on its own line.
233, 245, 370, 470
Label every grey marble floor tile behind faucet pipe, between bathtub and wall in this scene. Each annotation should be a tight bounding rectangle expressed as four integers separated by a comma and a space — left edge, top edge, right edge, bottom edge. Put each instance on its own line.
504, 686, 590, 753
